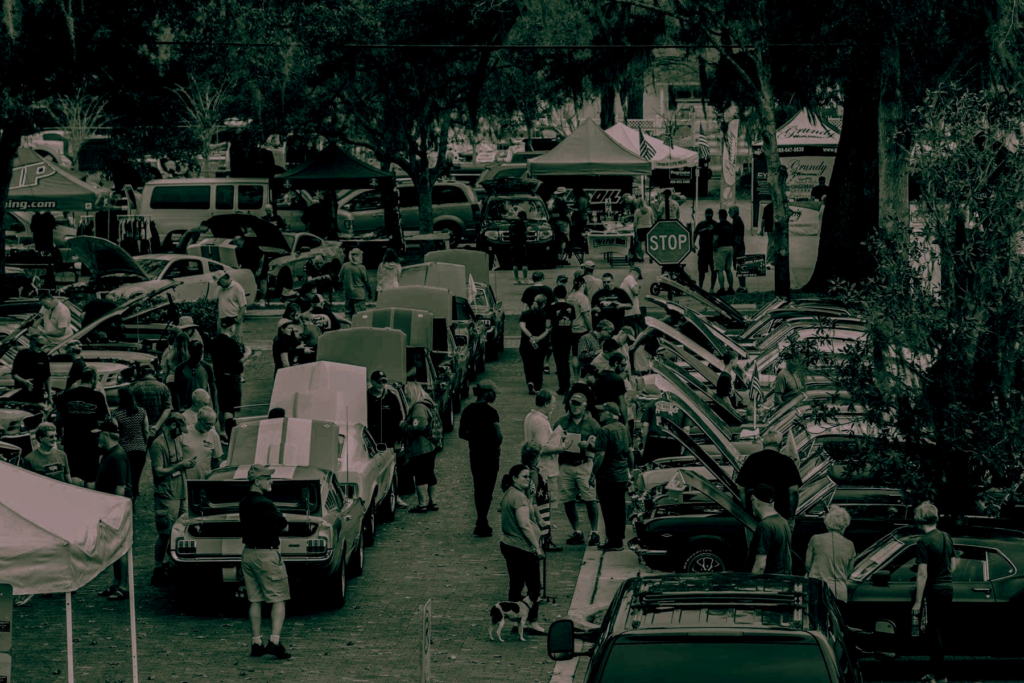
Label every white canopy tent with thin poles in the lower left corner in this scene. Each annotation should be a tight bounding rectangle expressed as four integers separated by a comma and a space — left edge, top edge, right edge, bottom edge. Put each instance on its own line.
0, 463, 138, 683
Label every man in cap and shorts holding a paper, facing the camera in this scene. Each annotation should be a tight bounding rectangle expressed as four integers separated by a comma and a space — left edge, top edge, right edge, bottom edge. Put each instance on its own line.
555, 392, 601, 546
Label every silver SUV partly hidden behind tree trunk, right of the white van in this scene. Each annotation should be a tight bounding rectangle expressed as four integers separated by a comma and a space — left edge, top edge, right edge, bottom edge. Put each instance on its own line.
338, 180, 480, 244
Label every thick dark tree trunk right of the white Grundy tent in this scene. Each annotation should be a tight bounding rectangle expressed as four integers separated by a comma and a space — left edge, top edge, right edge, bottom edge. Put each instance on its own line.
803, 71, 880, 294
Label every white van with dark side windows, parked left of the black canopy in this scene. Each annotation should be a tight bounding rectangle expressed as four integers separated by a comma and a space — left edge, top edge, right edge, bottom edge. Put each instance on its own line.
139, 178, 270, 238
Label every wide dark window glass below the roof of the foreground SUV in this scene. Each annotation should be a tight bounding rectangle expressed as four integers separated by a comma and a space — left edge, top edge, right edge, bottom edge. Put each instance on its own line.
601, 634, 831, 683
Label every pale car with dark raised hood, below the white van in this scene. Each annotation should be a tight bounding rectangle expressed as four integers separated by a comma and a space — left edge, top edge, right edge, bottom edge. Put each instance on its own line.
62, 237, 256, 303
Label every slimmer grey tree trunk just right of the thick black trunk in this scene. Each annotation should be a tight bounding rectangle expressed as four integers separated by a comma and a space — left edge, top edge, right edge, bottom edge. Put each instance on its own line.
878, 30, 910, 244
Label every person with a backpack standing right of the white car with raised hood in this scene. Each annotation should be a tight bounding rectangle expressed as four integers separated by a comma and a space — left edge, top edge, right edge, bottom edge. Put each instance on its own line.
401, 382, 444, 514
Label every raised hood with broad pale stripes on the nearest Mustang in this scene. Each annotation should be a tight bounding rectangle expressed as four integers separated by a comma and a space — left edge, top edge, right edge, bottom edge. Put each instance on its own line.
227, 417, 339, 472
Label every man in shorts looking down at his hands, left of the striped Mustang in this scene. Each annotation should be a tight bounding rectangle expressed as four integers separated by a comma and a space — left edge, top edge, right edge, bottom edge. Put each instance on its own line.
150, 413, 196, 586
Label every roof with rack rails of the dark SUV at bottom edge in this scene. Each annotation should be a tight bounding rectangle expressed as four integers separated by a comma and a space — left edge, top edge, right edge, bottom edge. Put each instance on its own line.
611, 572, 827, 633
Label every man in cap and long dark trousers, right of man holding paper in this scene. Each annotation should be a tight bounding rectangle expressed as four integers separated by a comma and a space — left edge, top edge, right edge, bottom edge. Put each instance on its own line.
594, 403, 633, 552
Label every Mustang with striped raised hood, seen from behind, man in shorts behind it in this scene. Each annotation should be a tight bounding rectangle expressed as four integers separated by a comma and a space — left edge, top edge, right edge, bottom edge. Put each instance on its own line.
170, 418, 366, 607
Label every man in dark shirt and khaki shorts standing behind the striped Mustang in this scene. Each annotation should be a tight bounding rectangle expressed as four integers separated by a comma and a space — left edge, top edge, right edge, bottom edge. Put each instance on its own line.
239, 464, 290, 659
